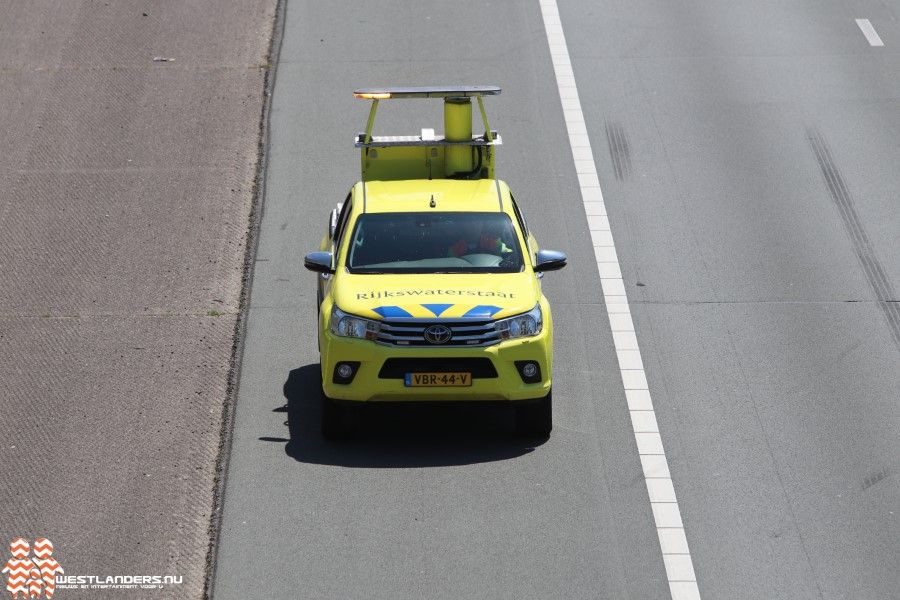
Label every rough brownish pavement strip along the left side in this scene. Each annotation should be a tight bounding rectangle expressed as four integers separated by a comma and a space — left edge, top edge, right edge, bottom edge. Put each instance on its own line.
0, 0, 275, 600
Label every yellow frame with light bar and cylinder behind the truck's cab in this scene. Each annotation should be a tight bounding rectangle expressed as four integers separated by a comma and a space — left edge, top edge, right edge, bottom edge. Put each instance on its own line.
353, 85, 502, 181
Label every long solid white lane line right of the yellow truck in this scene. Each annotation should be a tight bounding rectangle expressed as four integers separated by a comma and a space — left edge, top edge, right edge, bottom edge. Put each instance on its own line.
539, 0, 704, 600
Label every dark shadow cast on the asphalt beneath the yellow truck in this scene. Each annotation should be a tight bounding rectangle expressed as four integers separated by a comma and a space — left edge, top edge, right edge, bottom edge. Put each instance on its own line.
268, 364, 546, 468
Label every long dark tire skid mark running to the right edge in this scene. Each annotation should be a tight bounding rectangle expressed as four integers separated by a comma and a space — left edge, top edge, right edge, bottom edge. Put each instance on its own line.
806, 127, 900, 349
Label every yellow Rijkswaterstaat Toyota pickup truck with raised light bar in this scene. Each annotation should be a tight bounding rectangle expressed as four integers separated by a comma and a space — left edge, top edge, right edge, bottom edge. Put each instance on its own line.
304, 86, 566, 438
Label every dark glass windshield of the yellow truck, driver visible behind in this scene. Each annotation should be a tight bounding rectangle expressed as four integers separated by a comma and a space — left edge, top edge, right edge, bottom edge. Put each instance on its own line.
346, 212, 523, 273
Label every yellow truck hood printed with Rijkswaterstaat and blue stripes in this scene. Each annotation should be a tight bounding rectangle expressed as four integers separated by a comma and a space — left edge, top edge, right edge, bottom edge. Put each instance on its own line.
332, 272, 541, 319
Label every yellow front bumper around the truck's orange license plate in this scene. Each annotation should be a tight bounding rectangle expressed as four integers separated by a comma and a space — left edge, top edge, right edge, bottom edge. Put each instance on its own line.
320, 322, 553, 402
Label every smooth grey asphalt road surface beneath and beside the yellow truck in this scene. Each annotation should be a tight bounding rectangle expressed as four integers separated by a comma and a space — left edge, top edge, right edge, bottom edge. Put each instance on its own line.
213, 0, 900, 600
